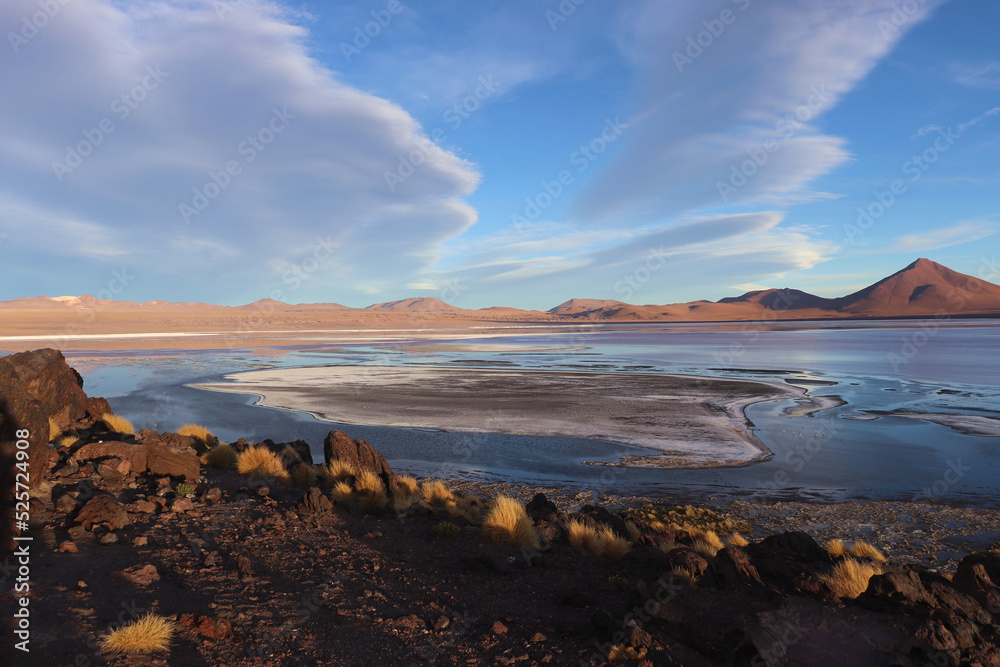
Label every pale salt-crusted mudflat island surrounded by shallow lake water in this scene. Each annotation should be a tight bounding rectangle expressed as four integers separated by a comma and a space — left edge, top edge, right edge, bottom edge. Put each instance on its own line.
186, 366, 804, 469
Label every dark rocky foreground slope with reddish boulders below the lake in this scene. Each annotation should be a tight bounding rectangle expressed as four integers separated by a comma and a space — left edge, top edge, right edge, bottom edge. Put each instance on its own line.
0, 351, 1000, 667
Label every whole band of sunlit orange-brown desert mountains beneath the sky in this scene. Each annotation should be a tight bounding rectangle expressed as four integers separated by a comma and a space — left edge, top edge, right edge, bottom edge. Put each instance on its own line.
0, 259, 1000, 322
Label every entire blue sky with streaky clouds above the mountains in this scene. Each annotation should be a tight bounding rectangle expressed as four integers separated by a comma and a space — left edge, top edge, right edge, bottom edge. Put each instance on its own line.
0, 0, 1000, 309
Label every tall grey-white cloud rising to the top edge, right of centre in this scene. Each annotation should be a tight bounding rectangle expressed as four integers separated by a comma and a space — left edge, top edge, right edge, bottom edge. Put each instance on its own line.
576, 0, 941, 223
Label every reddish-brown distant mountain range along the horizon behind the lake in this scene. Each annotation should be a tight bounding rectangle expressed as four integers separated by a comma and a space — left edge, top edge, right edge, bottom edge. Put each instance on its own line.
0, 258, 1000, 333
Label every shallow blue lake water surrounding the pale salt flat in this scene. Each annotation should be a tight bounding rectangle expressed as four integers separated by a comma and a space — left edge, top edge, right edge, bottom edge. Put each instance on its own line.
29, 320, 1000, 503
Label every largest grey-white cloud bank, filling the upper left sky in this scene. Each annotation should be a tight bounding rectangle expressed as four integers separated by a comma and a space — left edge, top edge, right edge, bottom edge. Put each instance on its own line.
0, 0, 479, 300
